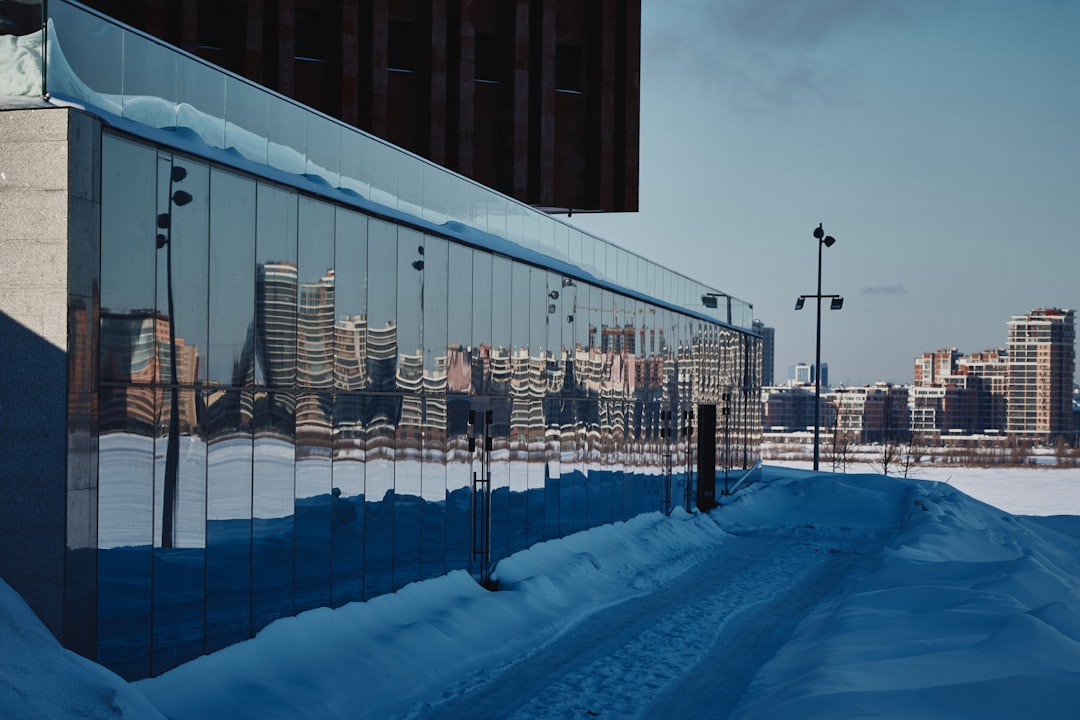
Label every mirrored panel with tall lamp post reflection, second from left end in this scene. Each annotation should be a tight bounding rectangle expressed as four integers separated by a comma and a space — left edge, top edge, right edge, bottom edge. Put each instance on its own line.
152, 155, 210, 674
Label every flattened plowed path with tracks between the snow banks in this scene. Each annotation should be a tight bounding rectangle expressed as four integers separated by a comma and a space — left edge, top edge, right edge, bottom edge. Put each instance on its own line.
417, 529, 877, 720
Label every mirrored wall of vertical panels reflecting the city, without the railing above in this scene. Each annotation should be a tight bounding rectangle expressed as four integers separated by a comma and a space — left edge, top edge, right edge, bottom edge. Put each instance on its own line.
97, 132, 760, 677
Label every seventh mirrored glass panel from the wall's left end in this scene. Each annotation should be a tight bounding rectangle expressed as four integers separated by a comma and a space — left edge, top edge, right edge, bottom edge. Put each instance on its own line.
364, 220, 401, 597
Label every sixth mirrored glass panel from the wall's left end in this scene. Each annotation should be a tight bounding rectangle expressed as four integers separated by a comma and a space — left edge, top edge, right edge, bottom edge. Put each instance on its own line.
330, 207, 369, 607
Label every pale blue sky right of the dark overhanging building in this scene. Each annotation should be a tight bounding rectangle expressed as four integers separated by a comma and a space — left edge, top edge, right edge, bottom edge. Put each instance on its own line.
570, 0, 1080, 384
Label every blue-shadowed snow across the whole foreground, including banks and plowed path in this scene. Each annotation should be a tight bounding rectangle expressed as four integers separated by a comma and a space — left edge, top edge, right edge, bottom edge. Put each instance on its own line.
0, 465, 1080, 720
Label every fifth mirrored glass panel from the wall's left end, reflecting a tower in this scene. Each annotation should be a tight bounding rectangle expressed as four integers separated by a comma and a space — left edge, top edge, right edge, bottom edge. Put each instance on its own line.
294, 198, 336, 612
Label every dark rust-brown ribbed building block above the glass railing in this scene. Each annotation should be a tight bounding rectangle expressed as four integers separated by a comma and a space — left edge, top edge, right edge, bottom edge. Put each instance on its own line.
87, 0, 642, 212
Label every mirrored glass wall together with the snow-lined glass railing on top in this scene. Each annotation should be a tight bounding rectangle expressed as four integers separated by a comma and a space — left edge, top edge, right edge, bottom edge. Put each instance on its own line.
2, 1, 761, 679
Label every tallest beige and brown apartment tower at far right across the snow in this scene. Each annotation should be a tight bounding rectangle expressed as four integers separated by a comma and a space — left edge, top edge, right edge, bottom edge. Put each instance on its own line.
1005, 308, 1076, 440
